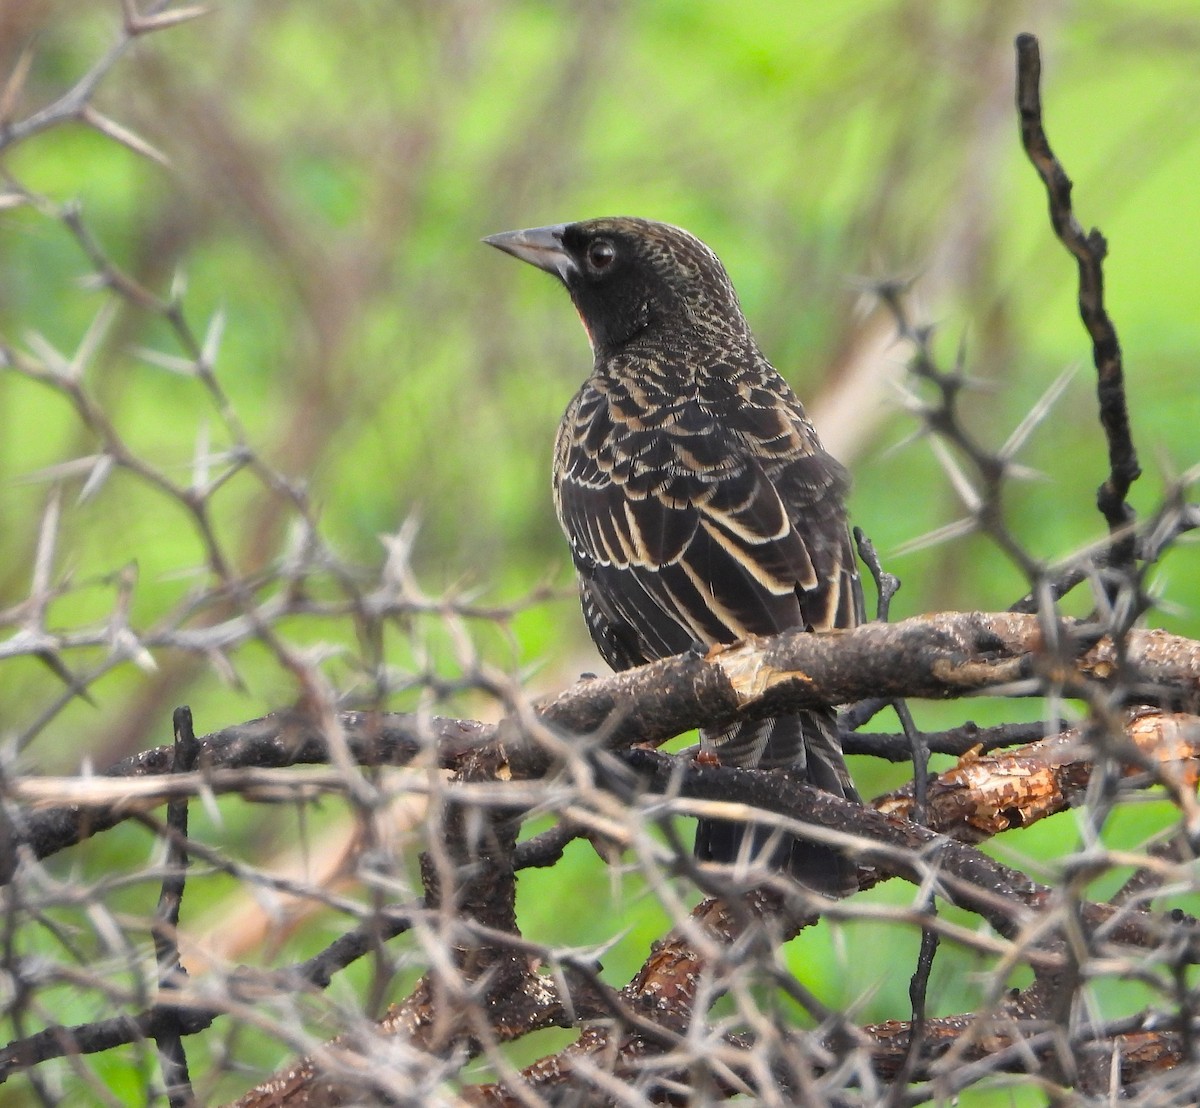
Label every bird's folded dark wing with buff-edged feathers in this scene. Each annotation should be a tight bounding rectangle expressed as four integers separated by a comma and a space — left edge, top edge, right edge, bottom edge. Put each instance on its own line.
556, 390, 848, 669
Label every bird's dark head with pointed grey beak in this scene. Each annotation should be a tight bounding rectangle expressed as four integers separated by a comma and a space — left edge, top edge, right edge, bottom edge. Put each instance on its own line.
484, 216, 745, 354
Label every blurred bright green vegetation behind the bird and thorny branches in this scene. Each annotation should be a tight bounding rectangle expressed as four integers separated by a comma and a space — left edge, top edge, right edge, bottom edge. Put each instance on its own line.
0, 0, 1200, 1103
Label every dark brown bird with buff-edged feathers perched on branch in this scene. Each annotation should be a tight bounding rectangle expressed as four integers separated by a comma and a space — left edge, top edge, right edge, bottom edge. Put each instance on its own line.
484, 217, 864, 894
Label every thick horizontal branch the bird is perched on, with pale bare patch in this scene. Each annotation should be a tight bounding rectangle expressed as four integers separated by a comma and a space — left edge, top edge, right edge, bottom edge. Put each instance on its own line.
13, 612, 1200, 878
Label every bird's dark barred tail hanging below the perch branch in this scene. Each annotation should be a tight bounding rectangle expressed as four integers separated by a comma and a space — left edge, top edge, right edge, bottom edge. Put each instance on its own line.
696, 709, 862, 896
